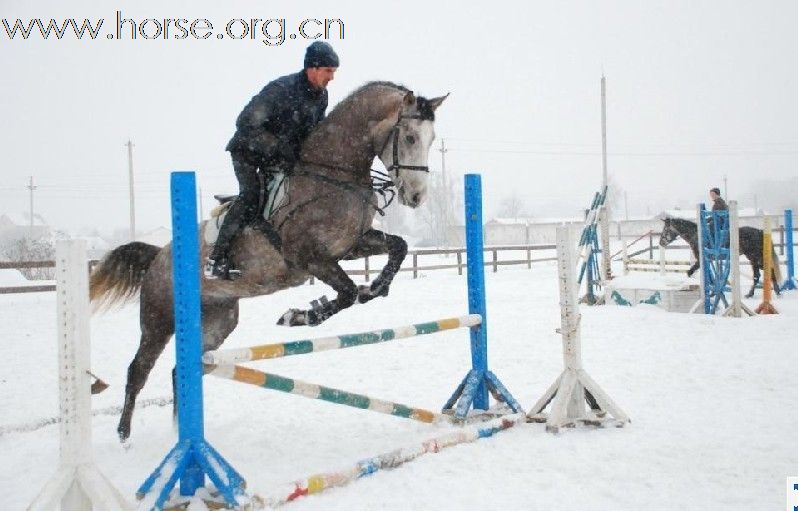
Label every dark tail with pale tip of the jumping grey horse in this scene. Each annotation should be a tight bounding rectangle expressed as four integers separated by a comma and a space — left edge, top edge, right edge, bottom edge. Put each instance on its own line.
89, 241, 161, 307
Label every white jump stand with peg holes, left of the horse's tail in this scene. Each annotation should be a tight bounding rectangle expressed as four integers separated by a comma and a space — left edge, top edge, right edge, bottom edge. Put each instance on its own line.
28, 240, 133, 511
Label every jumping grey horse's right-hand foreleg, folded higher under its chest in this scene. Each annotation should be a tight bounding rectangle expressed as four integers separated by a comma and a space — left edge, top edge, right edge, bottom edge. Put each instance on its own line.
345, 229, 407, 303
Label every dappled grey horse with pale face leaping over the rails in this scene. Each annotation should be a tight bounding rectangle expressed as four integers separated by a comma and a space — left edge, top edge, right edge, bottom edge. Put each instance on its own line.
90, 82, 446, 440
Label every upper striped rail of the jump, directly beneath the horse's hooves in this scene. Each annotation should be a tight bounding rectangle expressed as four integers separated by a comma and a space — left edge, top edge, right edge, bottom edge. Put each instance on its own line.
202, 314, 482, 365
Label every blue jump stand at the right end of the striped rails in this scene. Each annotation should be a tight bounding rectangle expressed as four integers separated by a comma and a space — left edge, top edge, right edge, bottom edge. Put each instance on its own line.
443, 174, 523, 419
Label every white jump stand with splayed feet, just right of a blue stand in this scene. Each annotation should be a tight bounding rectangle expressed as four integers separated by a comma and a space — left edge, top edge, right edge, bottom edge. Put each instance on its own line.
527, 226, 630, 433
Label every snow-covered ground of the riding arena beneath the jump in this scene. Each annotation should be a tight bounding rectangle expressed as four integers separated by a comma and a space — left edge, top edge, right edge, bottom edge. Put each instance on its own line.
0, 263, 798, 510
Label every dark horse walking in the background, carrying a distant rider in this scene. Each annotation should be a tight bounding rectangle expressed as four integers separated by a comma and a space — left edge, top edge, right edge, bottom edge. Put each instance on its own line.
659, 217, 781, 298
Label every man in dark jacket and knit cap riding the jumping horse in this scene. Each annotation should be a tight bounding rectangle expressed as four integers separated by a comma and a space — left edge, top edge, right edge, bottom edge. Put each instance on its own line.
204, 41, 339, 280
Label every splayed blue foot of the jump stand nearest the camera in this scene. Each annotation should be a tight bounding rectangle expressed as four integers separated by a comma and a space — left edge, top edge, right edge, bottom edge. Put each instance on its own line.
136, 440, 246, 510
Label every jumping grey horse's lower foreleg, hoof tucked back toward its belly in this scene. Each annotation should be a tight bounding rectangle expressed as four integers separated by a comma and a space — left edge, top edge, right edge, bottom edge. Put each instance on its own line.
277, 261, 357, 326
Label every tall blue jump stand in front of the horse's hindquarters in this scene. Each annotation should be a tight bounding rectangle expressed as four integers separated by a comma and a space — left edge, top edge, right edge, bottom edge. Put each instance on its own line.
137, 172, 248, 510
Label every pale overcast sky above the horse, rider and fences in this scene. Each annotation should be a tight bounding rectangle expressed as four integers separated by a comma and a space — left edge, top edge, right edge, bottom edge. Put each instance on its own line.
0, 0, 798, 230
